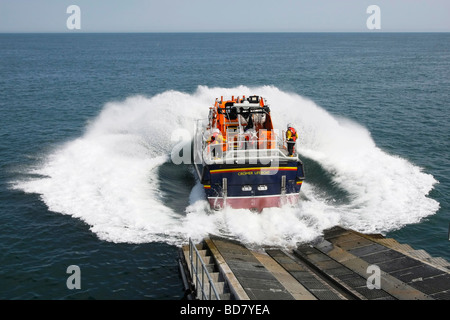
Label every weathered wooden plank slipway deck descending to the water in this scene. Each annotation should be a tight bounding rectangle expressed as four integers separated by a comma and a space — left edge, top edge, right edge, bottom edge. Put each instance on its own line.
181, 227, 450, 300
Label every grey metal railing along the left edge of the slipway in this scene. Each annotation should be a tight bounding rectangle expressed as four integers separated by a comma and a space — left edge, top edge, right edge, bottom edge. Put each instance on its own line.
189, 238, 220, 300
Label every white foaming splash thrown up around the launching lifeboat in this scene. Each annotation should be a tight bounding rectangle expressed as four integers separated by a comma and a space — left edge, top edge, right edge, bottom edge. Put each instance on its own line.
14, 86, 439, 246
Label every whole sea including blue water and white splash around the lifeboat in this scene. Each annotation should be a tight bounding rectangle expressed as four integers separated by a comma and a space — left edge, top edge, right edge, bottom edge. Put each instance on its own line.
0, 32, 450, 300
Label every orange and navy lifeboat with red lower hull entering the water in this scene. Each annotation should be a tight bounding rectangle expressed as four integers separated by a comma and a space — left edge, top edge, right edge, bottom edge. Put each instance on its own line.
192, 96, 305, 212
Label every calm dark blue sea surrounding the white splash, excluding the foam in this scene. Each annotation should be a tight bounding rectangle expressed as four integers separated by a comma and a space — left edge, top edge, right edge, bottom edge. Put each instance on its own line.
0, 33, 450, 299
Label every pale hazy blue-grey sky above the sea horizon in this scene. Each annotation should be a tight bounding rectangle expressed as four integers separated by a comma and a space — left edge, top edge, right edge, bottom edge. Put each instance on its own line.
0, 0, 450, 33
